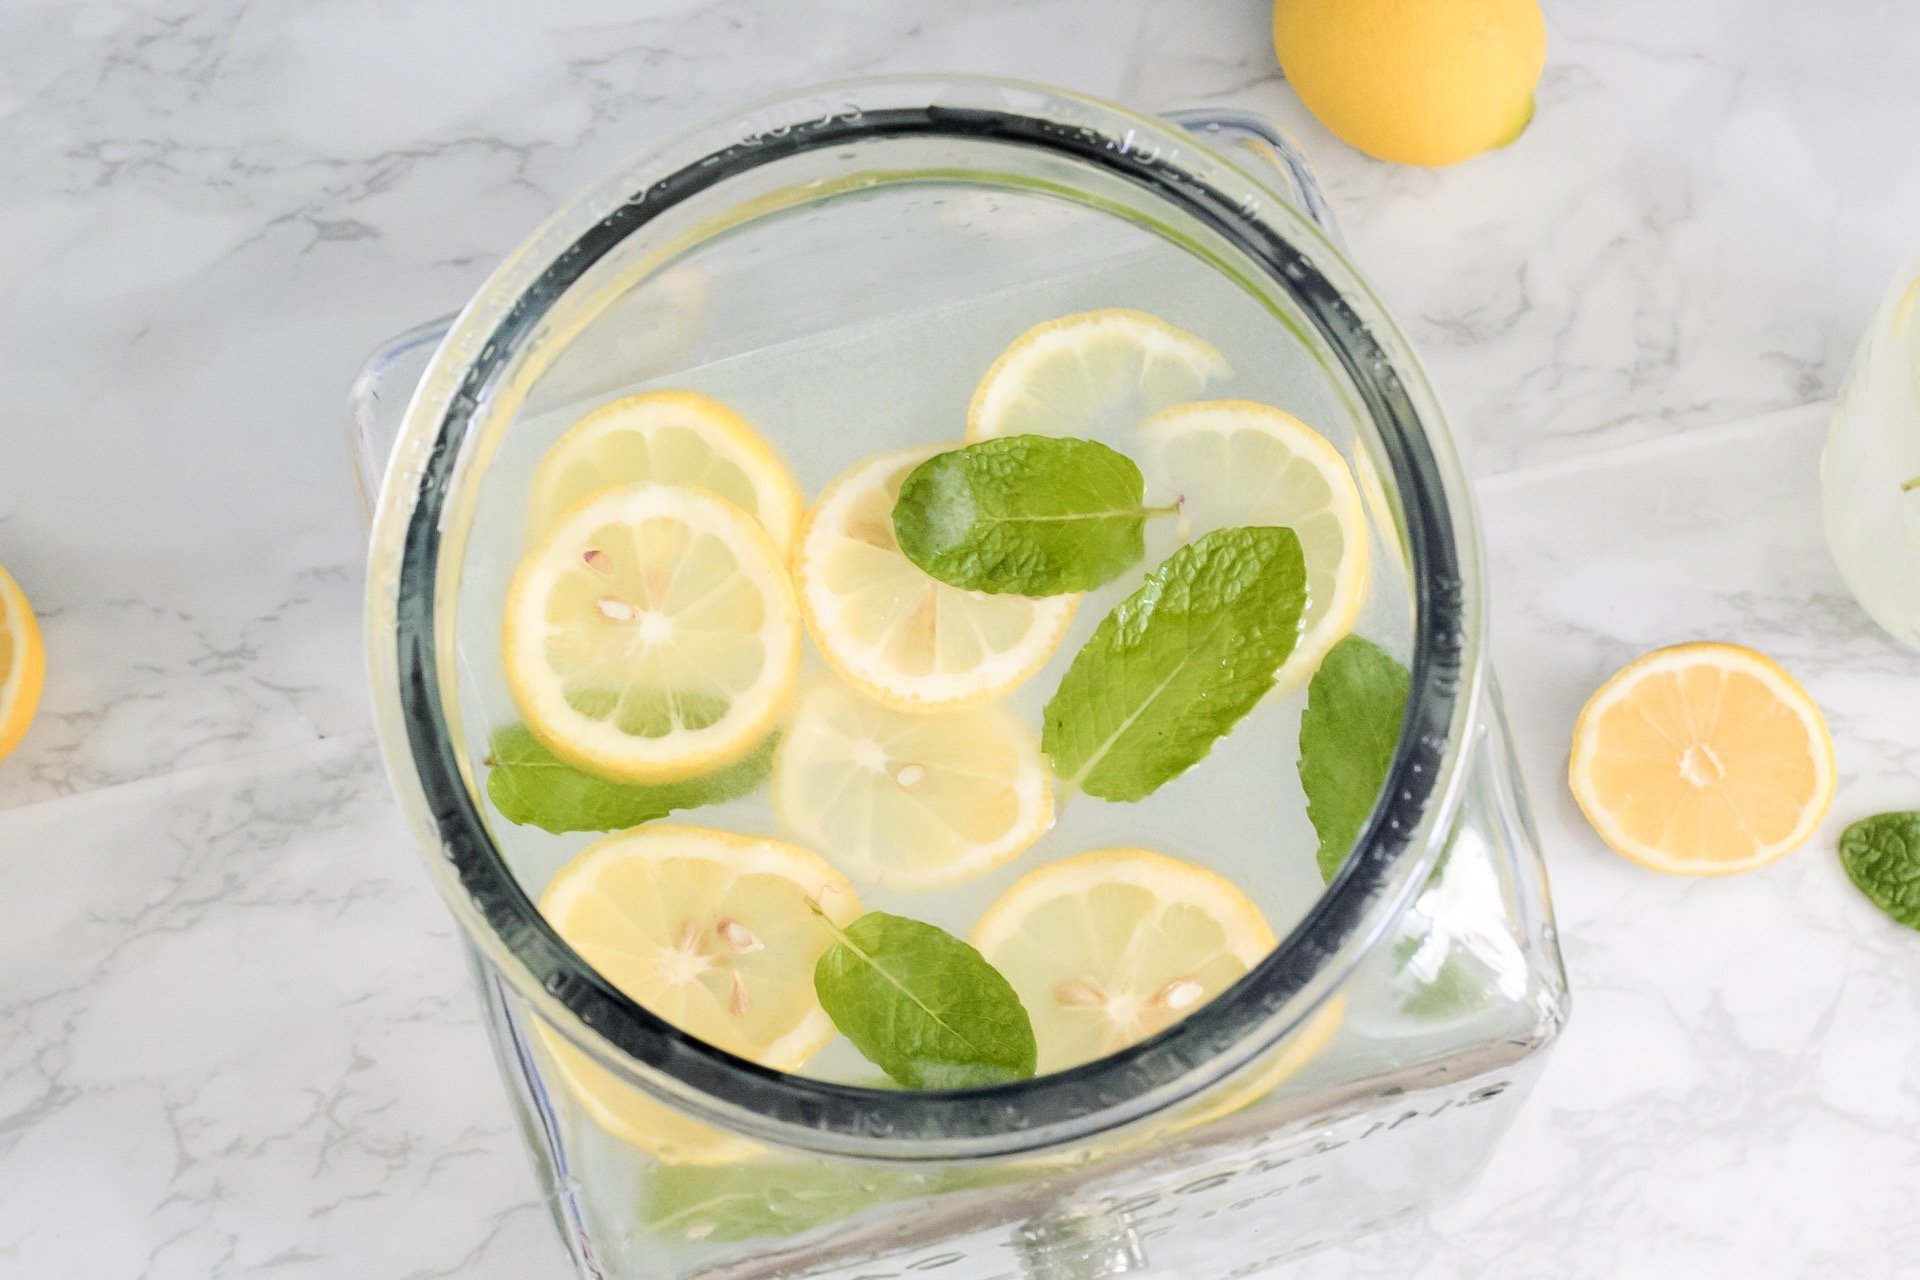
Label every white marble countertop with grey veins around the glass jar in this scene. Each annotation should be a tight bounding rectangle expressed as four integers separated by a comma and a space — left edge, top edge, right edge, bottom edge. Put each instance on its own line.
0, 0, 1920, 1280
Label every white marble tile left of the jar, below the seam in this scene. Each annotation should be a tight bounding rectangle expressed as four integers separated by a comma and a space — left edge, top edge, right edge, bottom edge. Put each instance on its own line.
0, 733, 564, 1280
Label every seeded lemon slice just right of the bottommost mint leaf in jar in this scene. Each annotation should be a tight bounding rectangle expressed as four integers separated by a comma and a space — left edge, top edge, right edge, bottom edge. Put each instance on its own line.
973, 848, 1273, 1071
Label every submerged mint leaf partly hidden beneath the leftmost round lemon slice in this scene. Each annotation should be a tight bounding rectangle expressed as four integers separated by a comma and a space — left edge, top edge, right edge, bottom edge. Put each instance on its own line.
486, 725, 774, 833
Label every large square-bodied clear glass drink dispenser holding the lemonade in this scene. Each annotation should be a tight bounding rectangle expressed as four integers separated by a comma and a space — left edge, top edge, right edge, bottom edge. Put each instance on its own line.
355, 79, 1567, 1280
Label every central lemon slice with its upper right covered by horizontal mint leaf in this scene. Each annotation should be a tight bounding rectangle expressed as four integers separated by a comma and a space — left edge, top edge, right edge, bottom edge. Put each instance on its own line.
793, 445, 1079, 710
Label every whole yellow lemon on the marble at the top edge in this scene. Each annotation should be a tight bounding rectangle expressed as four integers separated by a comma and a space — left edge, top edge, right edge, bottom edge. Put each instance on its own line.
1273, 0, 1548, 167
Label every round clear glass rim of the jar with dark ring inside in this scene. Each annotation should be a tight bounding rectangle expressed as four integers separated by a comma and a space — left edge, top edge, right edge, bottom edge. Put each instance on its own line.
367, 77, 1482, 1157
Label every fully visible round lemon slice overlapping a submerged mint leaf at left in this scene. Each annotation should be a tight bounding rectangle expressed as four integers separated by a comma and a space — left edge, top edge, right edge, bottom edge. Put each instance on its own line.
501, 484, 801, 783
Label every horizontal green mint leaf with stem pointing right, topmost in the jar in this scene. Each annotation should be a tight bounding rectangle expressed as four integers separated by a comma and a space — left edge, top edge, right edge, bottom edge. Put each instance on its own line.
893, 436, 1173, 595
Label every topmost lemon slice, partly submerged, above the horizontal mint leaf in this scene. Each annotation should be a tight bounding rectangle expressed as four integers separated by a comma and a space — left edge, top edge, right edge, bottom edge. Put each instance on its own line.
966, 307, 1231, 443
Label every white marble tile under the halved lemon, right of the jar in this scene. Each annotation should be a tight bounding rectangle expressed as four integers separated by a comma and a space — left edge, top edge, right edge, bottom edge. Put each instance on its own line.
1298, 409, 1920, 1280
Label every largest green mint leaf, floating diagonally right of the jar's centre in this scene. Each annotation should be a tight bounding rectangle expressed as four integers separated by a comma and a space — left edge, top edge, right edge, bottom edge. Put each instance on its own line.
1041, 528, 1308, 800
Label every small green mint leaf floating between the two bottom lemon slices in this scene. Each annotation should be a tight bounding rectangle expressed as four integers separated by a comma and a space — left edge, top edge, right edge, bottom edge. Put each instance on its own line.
814, 912, 1039, 1088
